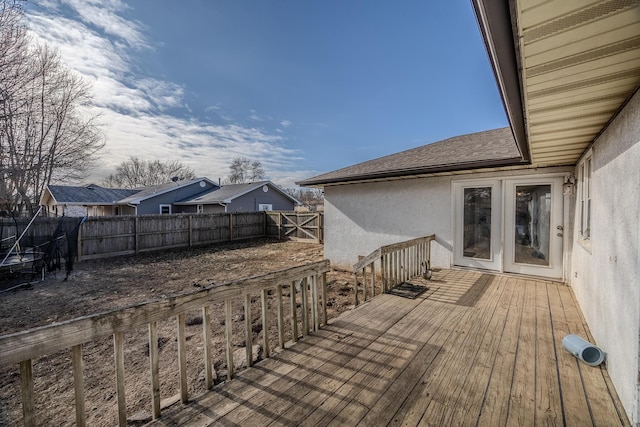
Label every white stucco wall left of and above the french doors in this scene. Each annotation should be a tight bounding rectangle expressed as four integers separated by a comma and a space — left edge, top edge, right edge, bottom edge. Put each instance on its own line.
324, 167, 573, 270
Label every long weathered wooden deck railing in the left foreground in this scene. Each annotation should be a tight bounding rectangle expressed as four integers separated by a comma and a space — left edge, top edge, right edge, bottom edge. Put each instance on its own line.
0, 260, 329, 426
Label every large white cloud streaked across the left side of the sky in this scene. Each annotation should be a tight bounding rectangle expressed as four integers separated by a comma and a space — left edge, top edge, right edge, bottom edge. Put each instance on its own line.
28, 0, 310, 187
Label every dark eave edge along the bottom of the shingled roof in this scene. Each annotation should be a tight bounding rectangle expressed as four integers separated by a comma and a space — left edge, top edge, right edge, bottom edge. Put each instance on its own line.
296, 157, 528, 187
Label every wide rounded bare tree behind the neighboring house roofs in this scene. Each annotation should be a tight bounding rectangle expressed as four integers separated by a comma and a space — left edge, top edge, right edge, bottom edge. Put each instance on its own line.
103, 157, 196, 188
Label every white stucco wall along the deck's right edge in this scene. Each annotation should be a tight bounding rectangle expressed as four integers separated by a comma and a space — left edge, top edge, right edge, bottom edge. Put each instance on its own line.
571, 92, 640, 425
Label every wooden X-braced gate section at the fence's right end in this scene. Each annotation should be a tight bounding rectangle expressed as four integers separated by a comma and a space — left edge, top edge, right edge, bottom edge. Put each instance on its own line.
266, 211, 324, 243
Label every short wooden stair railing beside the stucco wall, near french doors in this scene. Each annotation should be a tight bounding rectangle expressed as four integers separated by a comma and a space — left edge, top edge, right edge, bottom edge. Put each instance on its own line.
353, 234, 435, 305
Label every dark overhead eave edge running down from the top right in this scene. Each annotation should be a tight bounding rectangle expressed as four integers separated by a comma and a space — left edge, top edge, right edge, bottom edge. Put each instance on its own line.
471, 0, 531, 163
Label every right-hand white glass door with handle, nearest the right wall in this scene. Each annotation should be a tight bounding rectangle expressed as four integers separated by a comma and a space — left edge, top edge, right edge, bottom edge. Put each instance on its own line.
504, 177, 563, 278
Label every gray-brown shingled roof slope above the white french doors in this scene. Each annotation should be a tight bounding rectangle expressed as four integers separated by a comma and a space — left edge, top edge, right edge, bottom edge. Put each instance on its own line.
297, 128, 523, 186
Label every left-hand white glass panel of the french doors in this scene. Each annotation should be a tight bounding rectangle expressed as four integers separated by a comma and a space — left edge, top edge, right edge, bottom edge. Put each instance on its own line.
453, 180, 502, 270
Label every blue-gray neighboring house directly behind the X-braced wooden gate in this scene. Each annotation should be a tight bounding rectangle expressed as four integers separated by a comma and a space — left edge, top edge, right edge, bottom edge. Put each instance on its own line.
176, 181, 299, 213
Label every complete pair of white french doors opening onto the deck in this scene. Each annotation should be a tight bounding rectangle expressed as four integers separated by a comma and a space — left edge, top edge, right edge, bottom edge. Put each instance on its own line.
453, 177, 564, 278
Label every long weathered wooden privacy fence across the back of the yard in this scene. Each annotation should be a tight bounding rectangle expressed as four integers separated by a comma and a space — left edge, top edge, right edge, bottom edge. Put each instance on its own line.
0, 212, 323, 260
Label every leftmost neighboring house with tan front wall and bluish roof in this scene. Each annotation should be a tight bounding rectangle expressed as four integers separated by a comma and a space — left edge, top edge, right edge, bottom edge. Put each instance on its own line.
40, 184, 139, 217
